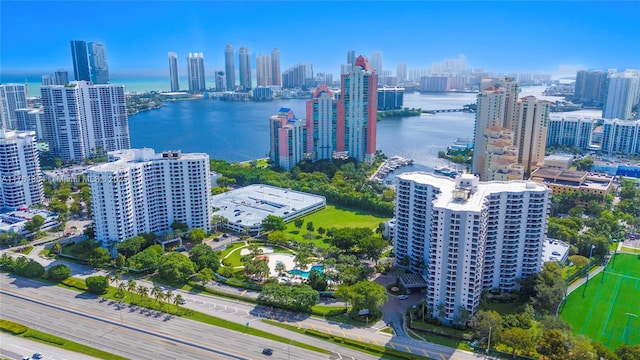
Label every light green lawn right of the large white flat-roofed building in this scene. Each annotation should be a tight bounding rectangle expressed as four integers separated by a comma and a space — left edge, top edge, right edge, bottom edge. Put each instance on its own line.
284, 205, 389, 248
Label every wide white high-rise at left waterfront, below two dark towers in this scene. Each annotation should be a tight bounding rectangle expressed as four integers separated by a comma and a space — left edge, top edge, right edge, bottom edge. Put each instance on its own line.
40, 81, 131, 161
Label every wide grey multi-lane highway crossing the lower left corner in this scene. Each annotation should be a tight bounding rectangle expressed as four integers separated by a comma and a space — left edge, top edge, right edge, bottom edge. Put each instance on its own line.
0, 274, 338, 360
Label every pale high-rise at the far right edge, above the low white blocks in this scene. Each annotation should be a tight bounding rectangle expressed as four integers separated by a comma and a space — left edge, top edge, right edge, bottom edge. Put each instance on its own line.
602, 70, 640, 120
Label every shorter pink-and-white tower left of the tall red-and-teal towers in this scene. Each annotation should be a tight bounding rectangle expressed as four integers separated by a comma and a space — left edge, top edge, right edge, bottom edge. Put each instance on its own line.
269, 108, 306, 170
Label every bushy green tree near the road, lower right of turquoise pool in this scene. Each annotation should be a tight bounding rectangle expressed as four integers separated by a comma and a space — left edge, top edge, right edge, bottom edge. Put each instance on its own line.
334, 280, 388, 317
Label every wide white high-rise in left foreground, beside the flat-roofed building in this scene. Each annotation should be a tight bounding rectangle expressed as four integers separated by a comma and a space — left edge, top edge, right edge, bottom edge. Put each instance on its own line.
87, 149, 212, 249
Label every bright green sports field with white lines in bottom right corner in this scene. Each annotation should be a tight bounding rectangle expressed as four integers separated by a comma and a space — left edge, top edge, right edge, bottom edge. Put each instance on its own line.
561, 254, 640, 349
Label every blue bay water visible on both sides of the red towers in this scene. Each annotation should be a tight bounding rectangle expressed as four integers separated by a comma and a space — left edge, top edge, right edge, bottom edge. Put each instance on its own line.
129, 94, 475, 167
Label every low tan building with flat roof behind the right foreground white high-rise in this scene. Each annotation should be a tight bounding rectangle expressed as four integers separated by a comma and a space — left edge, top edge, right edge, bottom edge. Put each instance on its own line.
531, 167, 614, 198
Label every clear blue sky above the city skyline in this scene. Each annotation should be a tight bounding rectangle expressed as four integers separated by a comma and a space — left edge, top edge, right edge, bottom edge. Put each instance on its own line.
0, 0, 640, 75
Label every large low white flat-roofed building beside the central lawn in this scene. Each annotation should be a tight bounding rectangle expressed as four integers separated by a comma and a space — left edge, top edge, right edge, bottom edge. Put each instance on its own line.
212, 185, 327, 235
